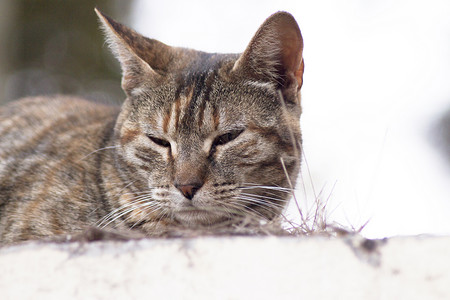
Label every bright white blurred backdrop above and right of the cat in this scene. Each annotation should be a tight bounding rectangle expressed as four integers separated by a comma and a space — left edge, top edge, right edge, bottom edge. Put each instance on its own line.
130, 0, 450, 237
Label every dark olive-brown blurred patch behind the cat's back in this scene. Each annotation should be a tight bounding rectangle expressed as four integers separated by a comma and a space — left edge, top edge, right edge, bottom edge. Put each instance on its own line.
2, 0, 132, 103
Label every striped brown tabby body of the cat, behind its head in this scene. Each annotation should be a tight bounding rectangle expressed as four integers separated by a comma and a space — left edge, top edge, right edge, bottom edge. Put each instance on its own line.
0, 97, 119, 243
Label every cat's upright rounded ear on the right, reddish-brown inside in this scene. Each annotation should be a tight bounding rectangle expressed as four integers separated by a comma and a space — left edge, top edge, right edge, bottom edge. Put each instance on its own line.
232, 12, 304, 102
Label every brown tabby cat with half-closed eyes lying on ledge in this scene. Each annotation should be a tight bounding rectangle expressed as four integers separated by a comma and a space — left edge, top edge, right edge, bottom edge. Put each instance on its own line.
0, 9, 304, 245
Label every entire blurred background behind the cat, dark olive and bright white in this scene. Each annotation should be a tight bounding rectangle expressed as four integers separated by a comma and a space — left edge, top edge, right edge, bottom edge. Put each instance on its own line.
0, 0, 450, 237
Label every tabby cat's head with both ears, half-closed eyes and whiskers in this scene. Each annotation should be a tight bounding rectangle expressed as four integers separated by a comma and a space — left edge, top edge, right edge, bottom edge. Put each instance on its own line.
97, 8, 304, 225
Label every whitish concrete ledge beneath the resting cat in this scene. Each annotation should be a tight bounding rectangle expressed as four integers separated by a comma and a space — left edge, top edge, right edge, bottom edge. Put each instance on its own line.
0, 237, 450, 299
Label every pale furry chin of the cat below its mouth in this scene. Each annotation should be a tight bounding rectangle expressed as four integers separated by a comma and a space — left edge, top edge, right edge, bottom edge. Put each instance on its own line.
174, 209, 227, 226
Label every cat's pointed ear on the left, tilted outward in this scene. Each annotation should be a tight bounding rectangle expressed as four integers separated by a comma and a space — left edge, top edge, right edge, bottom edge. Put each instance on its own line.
95, 8, 173, 96
